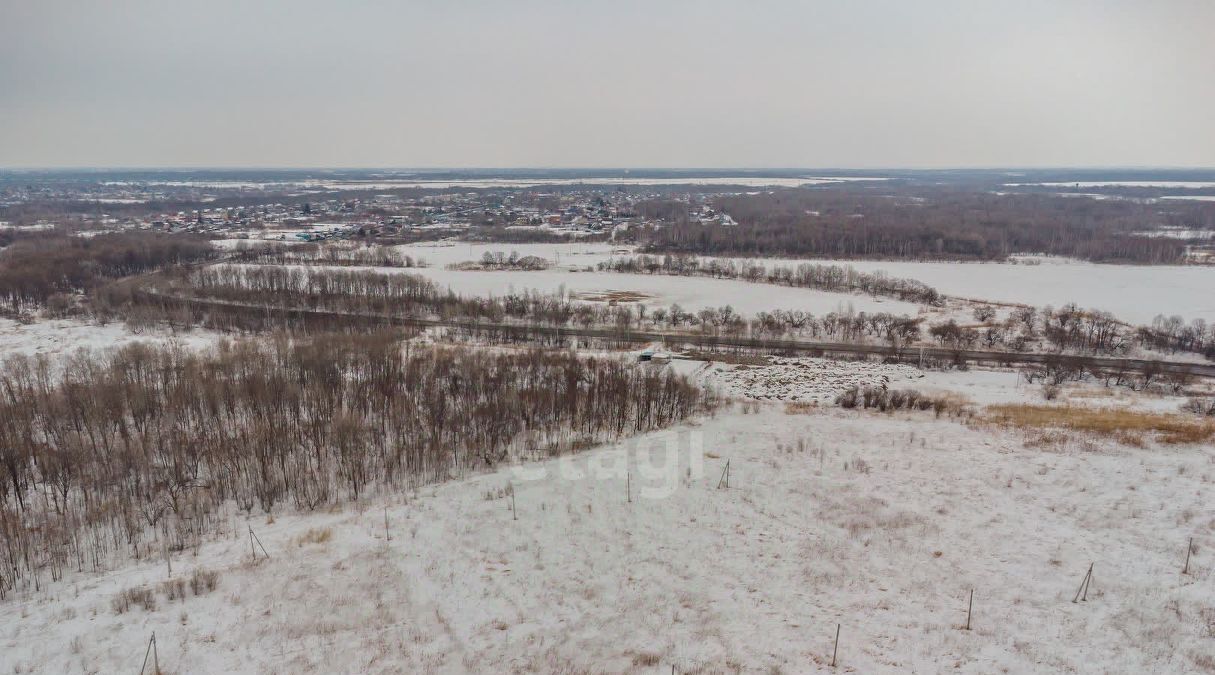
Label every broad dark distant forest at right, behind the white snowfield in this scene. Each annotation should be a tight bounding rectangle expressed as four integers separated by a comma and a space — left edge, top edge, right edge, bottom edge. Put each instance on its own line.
640, 188, 1215, 265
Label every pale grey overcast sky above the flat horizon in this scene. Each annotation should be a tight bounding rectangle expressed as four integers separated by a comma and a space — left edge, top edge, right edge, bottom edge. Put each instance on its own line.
0, 0, 1215, 168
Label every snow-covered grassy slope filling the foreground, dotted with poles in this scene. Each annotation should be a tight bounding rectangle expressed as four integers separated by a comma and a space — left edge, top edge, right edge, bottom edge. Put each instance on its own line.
0, 364, 1215, 674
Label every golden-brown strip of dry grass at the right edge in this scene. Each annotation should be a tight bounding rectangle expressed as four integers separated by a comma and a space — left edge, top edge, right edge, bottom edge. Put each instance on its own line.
983, 404, 1215, 446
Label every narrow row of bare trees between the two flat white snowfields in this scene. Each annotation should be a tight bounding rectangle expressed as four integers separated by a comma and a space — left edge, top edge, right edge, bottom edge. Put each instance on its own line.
599, 255, 944, 305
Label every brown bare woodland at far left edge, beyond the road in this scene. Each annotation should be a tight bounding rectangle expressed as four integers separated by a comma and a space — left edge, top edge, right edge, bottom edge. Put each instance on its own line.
0, 233, 216, 312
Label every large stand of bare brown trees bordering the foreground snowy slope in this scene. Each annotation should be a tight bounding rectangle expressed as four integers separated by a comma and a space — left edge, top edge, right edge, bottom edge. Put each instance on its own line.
0, 334, 713, 594
